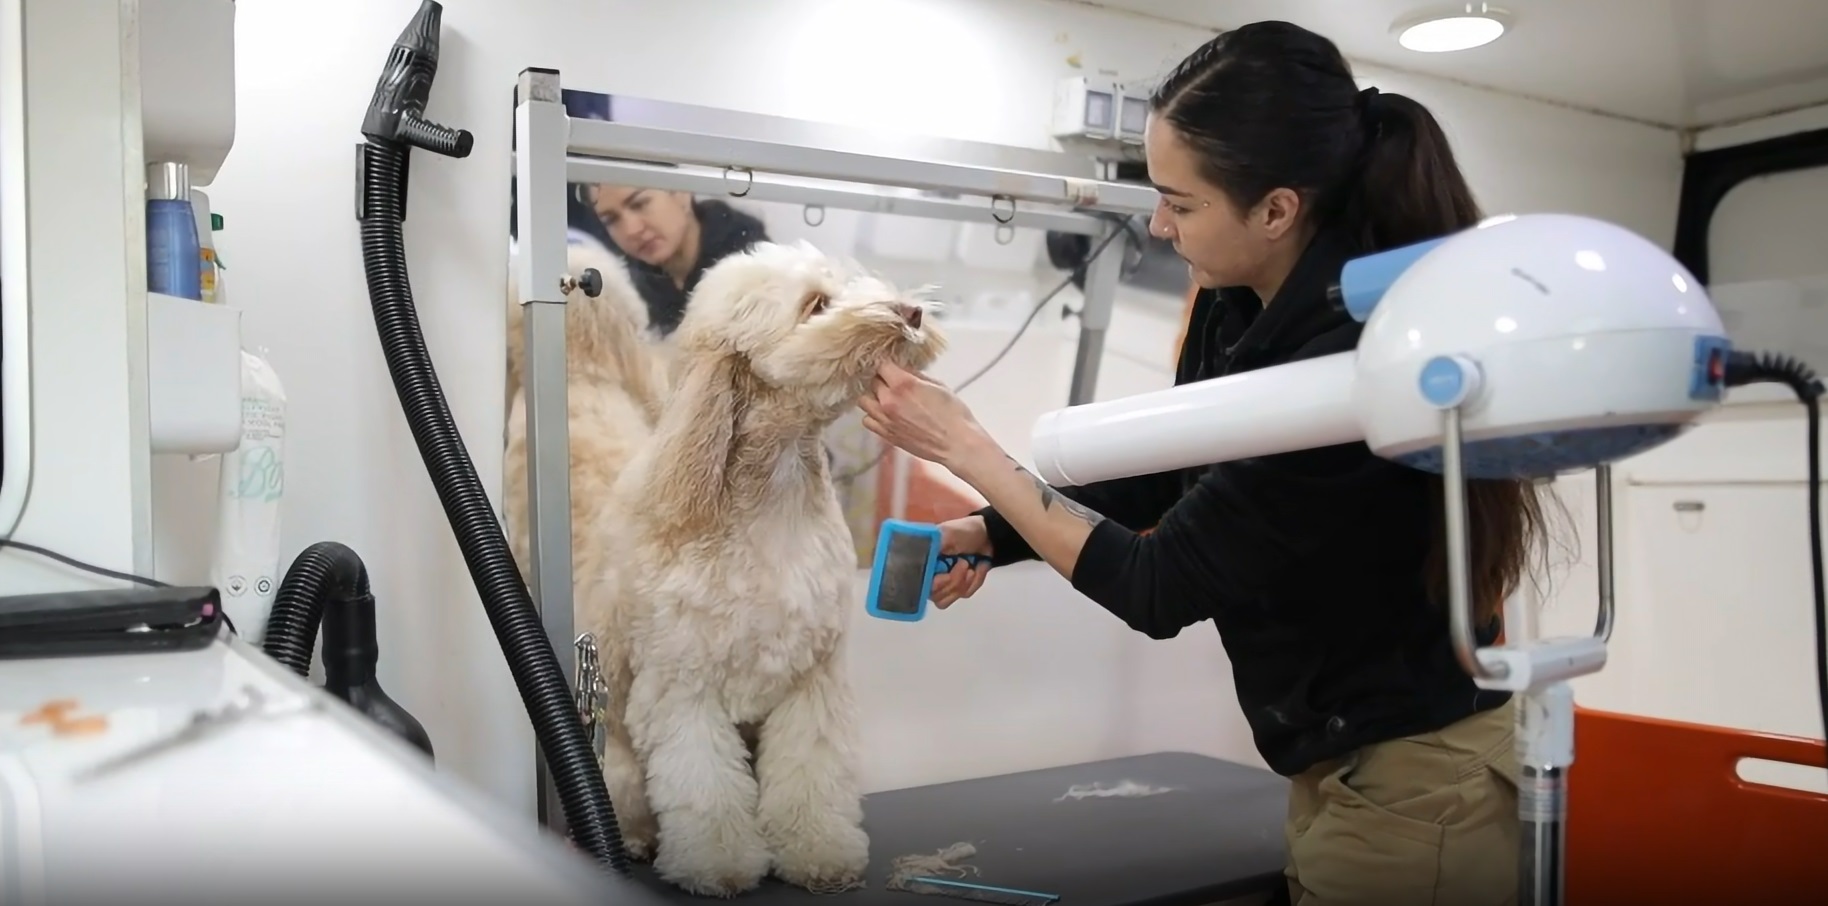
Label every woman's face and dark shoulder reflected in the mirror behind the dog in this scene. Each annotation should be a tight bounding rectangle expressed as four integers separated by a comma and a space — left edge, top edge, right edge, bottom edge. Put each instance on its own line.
589, 184, 768, 336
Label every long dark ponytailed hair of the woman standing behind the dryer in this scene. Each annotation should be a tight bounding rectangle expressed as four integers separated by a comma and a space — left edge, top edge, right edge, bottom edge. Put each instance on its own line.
1150, 22, 1546, 619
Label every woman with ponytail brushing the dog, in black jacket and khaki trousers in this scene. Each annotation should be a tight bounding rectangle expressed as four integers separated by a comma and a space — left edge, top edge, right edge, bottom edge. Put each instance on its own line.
861, 22, 1541, 906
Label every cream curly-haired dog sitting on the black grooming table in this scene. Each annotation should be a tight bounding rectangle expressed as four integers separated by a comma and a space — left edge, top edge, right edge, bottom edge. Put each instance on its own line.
579, 243, 943, 897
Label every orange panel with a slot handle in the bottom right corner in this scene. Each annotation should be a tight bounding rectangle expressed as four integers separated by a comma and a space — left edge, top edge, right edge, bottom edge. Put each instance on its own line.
1567, 709, 1828, 906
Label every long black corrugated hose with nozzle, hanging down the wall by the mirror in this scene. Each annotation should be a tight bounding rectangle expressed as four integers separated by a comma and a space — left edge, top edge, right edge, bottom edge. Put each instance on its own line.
356, 0, 629, 873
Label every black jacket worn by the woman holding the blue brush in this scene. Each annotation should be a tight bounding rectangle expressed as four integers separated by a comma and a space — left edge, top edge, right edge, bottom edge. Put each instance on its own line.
980, 230, 1508, 776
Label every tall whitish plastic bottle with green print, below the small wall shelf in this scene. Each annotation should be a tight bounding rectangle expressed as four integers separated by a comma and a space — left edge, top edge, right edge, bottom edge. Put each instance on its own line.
210, 351, 285, 645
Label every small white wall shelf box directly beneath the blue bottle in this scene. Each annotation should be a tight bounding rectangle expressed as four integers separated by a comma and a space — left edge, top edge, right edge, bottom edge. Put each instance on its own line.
146, 292, 241, 453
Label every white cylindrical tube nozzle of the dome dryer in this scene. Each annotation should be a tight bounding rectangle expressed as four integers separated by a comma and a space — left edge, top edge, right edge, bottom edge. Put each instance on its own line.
1033, 353, 1364, 486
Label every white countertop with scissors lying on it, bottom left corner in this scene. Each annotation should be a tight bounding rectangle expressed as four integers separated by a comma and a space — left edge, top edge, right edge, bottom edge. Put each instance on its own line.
0, 641, 653, 906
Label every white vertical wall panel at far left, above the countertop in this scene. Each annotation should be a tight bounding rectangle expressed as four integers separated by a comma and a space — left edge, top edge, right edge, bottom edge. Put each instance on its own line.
0, 0, 152, 594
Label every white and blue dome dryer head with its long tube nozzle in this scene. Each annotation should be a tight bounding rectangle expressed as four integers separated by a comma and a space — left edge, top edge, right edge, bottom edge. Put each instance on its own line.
1033, 214, 1731, 484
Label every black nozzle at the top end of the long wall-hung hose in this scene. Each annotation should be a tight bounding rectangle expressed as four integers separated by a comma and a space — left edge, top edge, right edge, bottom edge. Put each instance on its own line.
362, 0, 475, 157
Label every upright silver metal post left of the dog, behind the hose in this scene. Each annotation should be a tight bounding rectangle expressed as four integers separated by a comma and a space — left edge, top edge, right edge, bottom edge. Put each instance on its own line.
514, 69, 578, 835
